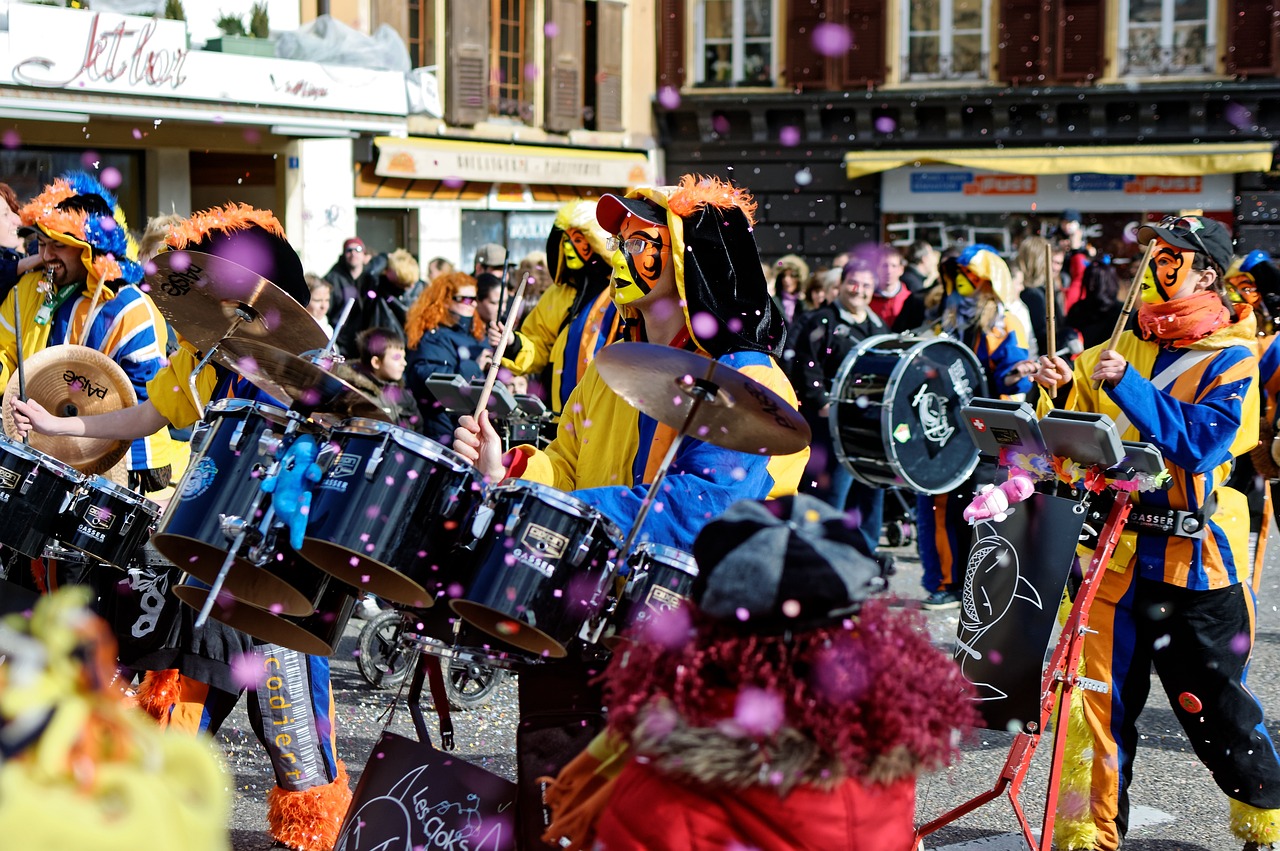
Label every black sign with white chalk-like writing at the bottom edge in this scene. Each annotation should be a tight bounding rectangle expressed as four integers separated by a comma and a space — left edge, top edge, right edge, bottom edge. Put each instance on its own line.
334, 733, 516, 851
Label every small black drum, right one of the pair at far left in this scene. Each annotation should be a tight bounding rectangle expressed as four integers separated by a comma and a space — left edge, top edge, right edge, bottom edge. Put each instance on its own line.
54, 476, 160, 569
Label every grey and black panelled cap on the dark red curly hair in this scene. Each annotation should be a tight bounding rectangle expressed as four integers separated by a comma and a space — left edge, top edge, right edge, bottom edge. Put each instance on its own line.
691, 494, 884, 632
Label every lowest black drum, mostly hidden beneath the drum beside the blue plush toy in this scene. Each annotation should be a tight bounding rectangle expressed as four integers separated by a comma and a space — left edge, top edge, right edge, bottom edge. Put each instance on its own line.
174, 575, 358, 656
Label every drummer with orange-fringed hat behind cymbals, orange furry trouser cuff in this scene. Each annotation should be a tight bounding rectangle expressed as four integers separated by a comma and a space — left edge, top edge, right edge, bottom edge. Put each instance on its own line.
13, 205, 351, 851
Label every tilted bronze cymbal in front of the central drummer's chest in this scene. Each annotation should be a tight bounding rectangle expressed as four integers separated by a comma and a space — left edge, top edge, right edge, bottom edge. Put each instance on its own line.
594, 343, 812, 456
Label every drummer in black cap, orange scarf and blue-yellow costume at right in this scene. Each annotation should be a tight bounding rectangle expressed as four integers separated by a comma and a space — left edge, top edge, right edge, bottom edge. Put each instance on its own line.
1037, 216, 1280, 851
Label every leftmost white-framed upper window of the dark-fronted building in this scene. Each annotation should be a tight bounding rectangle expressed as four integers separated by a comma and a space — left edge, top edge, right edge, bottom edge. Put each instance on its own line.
695, 0, 773, 86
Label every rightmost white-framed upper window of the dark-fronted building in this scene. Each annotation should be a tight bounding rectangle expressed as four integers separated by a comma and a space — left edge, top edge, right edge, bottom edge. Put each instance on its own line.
1120, 0, 1217, 76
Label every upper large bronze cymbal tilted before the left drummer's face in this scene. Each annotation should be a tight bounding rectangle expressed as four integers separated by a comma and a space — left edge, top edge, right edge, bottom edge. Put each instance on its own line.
146, 251, 329, 354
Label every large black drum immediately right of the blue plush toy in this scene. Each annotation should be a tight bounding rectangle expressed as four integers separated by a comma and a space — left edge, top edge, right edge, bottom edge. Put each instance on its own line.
302, 418, 480, 608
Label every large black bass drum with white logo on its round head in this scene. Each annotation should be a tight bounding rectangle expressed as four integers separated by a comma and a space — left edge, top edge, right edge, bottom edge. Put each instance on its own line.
828, 334, 987, 494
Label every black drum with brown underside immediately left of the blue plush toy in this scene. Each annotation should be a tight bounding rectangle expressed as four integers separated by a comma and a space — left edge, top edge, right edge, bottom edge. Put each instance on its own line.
151, 399, 319, 616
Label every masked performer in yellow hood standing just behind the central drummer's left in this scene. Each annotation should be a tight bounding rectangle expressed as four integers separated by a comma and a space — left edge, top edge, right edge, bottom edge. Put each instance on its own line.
490, 200, 618, 416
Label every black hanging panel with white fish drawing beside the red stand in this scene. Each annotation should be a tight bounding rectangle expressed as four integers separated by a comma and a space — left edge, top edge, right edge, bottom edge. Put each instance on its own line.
955, 494, 1084, 732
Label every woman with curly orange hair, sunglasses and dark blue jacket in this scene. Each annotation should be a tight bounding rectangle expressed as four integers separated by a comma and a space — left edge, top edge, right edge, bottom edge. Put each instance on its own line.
404, 271, 485, 445
